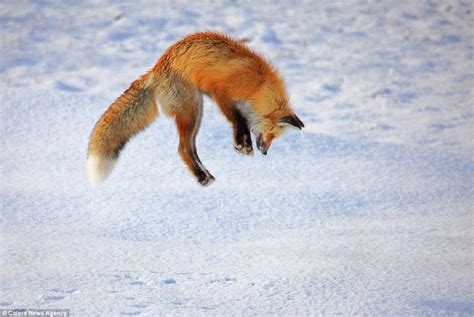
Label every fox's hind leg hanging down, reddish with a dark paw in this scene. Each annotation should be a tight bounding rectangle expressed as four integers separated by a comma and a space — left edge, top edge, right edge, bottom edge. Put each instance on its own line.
175, 96, 215, 186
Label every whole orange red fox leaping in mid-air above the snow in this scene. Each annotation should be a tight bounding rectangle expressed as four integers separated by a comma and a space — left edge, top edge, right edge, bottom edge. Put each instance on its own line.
87, 31, 304, 187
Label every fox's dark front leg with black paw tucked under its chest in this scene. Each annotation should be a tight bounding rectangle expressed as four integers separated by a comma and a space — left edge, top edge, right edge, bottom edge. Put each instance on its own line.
214, 96, 253, 155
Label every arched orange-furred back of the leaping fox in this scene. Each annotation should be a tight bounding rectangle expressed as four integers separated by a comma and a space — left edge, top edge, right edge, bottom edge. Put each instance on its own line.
156, 32, 278, 99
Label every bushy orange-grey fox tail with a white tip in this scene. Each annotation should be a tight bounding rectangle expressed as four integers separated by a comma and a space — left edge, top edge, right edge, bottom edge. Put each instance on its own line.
87, 73, 158, 186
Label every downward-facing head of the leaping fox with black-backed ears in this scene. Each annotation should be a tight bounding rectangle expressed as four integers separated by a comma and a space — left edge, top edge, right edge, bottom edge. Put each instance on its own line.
251, 111, 304, 155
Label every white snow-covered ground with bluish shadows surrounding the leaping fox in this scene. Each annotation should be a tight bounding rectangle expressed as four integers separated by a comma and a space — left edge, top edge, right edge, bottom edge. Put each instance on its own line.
0, 1, 474, 315
